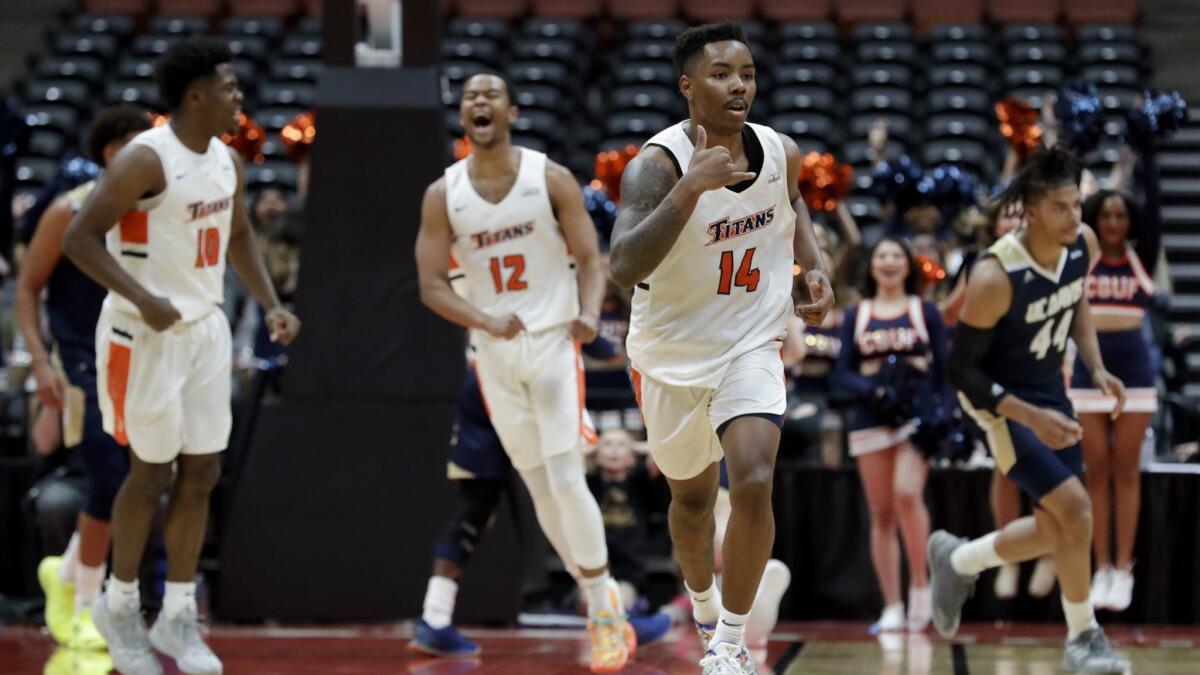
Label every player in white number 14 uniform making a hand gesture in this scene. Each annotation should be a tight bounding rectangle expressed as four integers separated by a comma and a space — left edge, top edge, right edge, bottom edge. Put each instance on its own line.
611, 23, 833, 675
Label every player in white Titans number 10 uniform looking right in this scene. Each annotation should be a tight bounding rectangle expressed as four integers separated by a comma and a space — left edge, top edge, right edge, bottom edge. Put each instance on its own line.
64, 38, 300, 675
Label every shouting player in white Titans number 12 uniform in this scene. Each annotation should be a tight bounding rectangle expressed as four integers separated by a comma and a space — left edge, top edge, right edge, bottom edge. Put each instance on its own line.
416, 73, 636, 673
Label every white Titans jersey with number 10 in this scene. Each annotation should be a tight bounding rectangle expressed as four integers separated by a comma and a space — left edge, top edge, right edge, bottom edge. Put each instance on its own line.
106, 124, 238, 322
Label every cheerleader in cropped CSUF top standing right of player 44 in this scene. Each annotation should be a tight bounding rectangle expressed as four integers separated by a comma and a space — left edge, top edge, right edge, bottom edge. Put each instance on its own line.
1070, 142, 1162, 611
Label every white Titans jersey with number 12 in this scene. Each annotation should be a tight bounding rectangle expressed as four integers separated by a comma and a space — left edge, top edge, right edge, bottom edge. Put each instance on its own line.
445, 148, 580, 333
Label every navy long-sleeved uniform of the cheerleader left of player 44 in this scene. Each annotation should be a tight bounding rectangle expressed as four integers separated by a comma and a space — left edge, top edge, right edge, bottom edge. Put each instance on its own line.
834, 295, 946, 456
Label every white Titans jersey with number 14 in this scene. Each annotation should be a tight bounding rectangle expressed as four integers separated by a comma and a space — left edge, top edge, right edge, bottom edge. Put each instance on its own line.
628, 123, 796, 388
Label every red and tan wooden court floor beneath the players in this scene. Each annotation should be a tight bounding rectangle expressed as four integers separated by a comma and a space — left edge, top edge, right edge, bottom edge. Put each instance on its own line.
0, 622, 1200, 675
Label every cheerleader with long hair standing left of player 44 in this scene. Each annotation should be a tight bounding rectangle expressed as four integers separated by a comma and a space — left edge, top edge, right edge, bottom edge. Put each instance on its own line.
835, 235, 946, 632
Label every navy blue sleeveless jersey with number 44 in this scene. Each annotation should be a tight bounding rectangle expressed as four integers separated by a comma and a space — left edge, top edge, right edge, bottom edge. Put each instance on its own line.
980, 231, 1088, 412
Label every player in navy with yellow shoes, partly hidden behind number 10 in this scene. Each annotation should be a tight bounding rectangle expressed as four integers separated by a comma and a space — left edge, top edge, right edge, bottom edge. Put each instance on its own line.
14, 106, 150, 650
